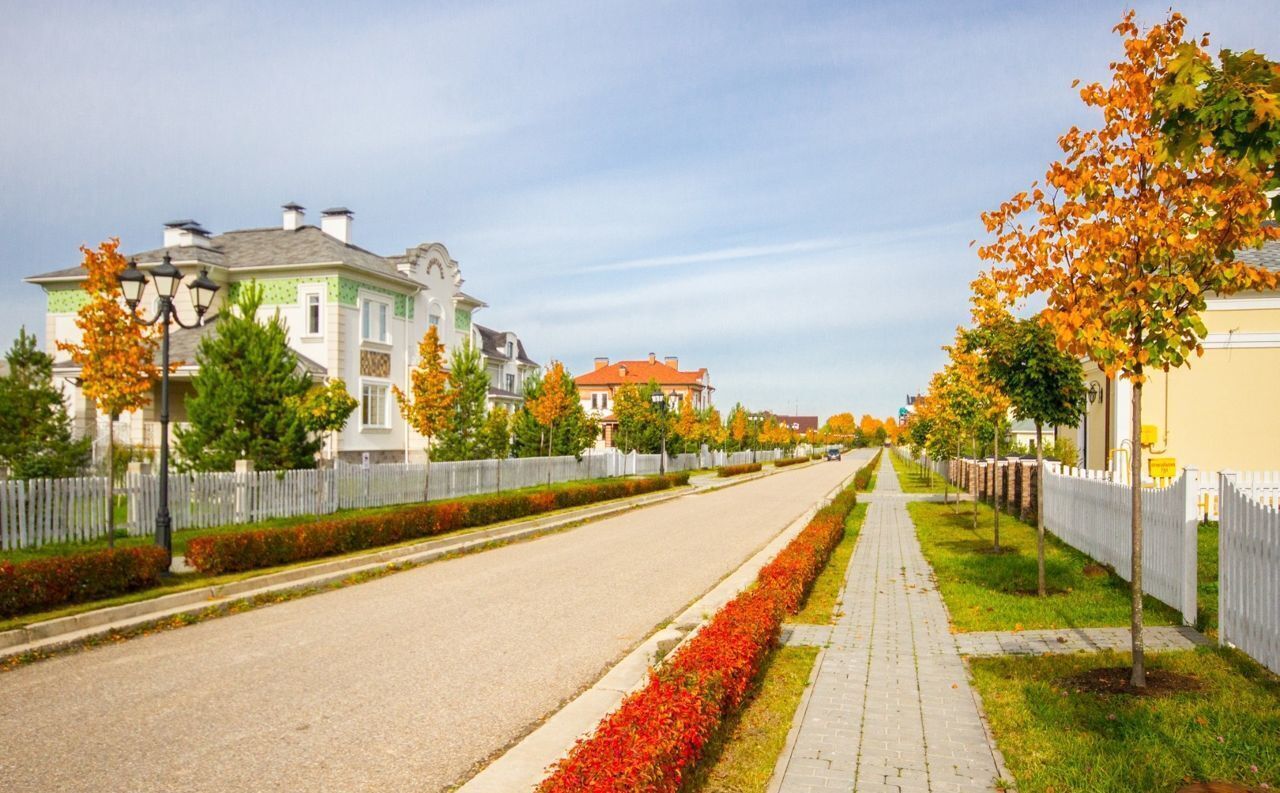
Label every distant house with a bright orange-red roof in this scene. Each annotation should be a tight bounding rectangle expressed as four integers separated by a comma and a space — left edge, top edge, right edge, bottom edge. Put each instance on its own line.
573, 353, 716, 448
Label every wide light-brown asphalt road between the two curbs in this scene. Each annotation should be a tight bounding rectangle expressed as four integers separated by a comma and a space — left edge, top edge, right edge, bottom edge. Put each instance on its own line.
0, 455, 861, 793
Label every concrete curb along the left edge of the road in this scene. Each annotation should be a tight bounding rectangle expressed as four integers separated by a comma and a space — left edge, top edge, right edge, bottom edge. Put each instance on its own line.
0, 457, 805, 661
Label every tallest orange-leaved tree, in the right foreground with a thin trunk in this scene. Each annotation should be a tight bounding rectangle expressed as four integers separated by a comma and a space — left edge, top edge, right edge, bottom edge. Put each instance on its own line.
979, 12, 1280, 688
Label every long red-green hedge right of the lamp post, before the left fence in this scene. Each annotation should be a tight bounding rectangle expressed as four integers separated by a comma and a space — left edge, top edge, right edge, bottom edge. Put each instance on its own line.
187, 472, 689, 574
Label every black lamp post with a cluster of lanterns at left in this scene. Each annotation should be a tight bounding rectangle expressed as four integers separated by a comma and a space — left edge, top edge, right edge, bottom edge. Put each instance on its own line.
119, 253, 218, 561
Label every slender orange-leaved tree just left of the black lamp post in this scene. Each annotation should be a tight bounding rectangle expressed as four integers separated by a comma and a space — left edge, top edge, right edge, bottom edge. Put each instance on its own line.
58, 238, 160, 547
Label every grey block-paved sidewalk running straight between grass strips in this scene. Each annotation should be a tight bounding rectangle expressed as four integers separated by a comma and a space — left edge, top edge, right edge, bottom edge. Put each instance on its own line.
774, 450, 1002, 793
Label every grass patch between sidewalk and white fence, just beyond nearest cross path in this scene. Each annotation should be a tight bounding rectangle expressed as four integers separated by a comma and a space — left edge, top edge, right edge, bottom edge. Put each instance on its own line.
908, 501, 1181, 631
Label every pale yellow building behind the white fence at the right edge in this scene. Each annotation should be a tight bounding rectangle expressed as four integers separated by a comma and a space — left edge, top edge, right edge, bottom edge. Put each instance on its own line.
1062, 242, 1280, 472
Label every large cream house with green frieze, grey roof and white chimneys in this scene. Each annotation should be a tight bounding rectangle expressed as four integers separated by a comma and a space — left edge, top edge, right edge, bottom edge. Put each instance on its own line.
26, 203, 539, 463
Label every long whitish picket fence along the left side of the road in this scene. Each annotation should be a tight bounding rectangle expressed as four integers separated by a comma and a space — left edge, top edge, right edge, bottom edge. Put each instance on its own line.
0, 449, 783, 550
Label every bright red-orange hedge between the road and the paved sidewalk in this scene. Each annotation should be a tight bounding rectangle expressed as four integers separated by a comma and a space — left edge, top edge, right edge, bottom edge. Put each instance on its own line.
538, 490, 856, 793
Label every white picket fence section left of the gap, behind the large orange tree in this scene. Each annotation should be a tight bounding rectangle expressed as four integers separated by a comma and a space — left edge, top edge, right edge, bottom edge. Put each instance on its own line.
1043, 463, 1199, 625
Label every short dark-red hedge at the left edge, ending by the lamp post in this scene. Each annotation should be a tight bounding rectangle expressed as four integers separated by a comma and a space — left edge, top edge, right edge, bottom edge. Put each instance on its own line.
0, 545, 169, 616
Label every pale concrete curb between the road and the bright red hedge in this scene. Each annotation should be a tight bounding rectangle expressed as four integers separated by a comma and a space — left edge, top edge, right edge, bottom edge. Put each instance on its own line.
457, 463, 856, 793
